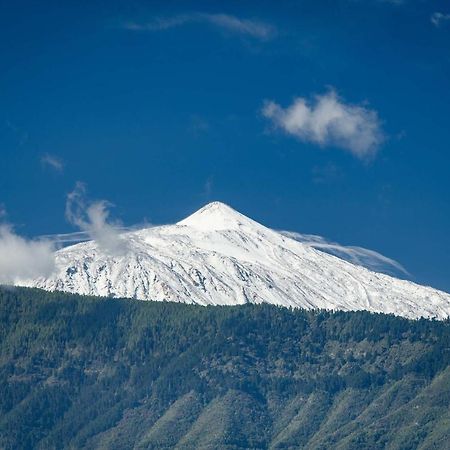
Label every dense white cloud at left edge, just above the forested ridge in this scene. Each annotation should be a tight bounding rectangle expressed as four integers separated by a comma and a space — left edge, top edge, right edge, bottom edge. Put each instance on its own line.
0, 224, 55, 284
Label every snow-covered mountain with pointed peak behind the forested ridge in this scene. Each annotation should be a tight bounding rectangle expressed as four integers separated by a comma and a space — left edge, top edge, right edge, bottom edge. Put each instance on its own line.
27, 202, 450, 319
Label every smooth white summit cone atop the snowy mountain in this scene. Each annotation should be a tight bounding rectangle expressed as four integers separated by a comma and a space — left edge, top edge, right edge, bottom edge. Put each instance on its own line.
177, 201, 255, 231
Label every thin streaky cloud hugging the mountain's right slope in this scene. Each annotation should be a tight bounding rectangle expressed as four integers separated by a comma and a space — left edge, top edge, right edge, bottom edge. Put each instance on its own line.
280, 231, 410, 277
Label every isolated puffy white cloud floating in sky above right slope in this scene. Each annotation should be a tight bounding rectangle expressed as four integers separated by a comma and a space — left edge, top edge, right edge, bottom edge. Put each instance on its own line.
262, 90, 384, 159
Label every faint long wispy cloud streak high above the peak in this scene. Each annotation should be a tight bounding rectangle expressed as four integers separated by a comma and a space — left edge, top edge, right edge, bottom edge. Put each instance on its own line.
124, 12, 277, 40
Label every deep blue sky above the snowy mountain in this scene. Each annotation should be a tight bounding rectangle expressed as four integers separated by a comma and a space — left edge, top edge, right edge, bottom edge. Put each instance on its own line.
0, 0, 450, 291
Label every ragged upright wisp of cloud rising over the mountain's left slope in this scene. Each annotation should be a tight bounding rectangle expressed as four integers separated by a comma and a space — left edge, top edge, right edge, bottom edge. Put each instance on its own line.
66, 182, 127, 256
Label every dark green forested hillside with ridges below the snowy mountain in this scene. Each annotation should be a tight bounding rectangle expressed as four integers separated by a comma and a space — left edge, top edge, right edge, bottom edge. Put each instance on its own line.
0, 288, 450, 449
